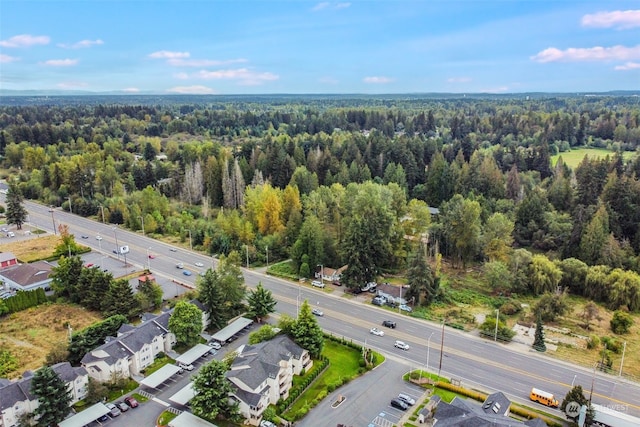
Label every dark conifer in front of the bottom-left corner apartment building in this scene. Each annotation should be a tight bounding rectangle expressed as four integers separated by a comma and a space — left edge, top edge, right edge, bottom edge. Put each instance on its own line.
31, 366, 71, 426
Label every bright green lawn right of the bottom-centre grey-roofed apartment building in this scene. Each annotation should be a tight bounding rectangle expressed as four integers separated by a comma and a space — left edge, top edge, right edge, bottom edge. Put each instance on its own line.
285, 340, 360, 415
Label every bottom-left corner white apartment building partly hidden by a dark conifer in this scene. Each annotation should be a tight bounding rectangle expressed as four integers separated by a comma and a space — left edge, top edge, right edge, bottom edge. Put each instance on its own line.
0, 362, 89, 427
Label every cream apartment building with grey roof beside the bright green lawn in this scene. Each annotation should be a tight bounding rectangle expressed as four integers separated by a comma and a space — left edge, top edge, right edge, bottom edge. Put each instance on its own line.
227, 335, 313, 426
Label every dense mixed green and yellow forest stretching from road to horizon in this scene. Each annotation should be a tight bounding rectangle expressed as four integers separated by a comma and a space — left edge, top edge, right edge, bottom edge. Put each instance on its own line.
0, 95, 640, 311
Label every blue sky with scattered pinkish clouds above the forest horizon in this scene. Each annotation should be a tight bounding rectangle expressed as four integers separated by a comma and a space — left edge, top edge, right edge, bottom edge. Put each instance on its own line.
0, 0, 640, 94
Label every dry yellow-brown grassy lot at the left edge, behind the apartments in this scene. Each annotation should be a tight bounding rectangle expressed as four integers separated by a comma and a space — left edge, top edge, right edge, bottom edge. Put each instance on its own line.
0, 304, 102, 378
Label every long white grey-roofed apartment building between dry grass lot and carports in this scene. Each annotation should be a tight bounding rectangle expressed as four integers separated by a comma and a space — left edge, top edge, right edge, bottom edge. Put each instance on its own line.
81, 312, 176, 382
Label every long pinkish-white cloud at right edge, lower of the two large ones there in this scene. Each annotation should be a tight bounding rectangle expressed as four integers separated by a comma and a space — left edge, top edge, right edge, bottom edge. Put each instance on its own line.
531, 45, 640, 62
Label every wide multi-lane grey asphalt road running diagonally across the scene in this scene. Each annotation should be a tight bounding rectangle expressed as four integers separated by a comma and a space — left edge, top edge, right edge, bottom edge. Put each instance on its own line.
12, 202, 640, 422
